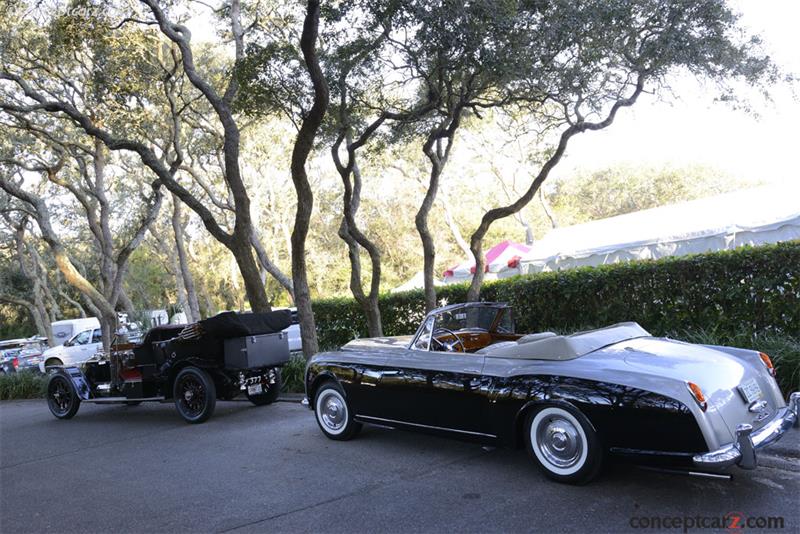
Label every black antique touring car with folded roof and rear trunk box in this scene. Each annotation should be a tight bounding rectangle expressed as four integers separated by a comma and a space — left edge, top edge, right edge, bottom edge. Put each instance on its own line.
47, 310, 291, 423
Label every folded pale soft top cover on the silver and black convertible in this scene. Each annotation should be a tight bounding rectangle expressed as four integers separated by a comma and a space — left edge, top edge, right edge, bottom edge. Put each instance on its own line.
480, 322, 650, 360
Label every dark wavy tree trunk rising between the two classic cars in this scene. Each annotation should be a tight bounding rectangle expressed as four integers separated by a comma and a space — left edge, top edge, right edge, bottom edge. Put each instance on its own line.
291, 0, 329, 358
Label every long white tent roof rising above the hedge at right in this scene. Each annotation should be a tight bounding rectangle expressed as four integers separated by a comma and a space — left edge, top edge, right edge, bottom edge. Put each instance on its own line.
520, 184, 800, 273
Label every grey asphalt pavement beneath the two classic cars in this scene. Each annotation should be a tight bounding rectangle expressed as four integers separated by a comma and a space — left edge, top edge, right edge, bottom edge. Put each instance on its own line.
0, 401, 800, 534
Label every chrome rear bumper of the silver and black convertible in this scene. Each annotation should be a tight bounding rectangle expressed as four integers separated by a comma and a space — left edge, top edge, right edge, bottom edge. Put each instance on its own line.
692, 392, 800, 469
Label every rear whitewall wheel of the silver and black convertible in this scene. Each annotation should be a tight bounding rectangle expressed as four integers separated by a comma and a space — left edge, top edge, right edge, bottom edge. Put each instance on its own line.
525, 404, 603, 484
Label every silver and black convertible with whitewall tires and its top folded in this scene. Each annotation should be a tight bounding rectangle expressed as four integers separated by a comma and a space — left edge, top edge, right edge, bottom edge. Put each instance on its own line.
305, 303, 800, 483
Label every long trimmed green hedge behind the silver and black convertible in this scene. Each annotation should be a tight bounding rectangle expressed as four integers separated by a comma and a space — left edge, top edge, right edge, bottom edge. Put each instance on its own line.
314, 241, 800, 348
